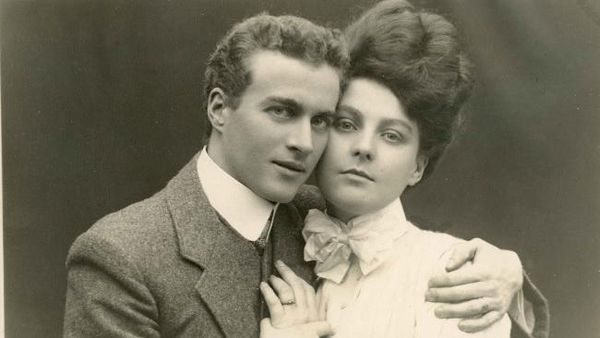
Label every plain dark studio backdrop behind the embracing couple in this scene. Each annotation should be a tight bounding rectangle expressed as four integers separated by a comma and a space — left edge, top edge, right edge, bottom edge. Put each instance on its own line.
1, 0, 600, 337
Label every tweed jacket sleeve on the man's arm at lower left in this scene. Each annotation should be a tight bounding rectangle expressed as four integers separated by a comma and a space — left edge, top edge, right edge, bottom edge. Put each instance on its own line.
64, 233, 160, 337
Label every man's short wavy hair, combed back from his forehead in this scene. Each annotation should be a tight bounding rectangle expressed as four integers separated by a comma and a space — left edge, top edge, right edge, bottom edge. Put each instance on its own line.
204, 13, 349, 135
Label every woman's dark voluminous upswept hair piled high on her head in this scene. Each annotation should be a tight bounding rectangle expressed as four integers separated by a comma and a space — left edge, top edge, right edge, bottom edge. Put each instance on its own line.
345, 0, 473, 178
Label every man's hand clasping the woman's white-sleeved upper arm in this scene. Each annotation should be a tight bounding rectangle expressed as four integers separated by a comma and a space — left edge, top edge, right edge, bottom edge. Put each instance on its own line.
425, 239, 523, 333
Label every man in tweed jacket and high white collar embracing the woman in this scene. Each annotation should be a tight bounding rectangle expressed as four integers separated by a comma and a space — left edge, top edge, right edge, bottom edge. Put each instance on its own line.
64, 11, 548, 337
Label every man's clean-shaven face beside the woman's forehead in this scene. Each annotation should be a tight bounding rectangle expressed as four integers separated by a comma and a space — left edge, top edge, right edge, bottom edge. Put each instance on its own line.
219, 51, 340, 202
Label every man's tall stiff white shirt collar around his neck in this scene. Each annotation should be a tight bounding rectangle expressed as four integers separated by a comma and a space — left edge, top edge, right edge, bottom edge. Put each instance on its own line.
197, 147, 276, 241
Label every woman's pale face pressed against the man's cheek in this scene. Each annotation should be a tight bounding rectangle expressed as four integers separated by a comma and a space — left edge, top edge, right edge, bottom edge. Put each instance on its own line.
316, 78, 427, 221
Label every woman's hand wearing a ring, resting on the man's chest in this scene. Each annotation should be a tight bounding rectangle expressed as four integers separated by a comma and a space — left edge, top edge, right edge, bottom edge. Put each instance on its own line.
260, 261, 321, 328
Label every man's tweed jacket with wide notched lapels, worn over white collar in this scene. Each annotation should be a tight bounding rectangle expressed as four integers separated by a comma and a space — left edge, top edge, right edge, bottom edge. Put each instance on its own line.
64, 154, 548, 338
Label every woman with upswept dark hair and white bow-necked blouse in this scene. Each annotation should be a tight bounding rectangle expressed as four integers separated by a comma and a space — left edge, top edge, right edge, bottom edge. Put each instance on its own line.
261, 1, 510, 338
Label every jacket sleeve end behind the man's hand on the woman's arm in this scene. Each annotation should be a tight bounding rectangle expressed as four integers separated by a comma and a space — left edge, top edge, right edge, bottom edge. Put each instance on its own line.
508, 271, 550, 338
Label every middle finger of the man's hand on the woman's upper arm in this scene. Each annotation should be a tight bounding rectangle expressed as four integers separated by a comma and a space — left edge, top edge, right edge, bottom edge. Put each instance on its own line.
425, 282, 496, 303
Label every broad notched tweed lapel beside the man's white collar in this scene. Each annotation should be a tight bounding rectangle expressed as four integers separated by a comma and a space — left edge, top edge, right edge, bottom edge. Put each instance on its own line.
167, 154, 260, 337
